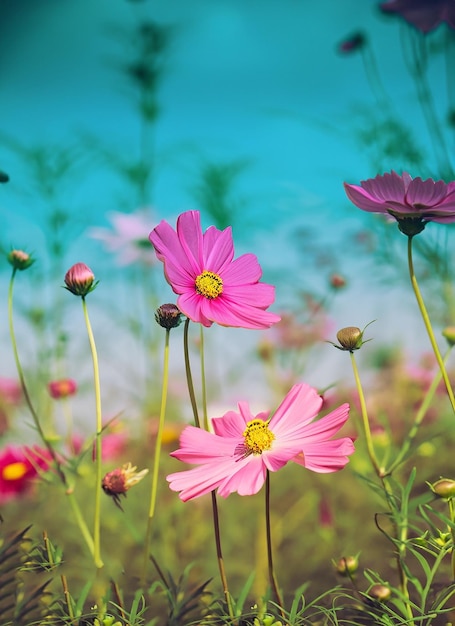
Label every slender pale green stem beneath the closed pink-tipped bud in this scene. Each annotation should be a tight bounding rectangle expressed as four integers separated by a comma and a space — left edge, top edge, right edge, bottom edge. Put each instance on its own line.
81, 296, 104, 568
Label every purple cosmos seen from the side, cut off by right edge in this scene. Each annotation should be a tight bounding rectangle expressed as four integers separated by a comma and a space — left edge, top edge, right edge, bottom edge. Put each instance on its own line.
344, 171, 455, 235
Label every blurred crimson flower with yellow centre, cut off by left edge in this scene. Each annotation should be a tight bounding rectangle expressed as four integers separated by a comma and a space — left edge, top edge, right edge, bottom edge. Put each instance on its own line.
0, 446, 49, 504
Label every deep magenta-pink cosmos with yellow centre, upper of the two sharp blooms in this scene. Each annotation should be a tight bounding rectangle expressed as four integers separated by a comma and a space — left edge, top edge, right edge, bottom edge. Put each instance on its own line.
150, 211, 280, 329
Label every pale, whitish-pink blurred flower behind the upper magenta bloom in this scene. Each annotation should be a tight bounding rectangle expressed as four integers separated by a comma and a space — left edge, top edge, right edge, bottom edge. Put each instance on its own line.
88, 208, 156, 265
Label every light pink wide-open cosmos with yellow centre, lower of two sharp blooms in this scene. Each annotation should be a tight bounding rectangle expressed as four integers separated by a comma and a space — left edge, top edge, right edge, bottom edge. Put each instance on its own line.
167, 383, 354, 502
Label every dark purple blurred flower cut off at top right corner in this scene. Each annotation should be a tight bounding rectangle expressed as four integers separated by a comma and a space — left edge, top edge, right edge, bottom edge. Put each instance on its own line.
380, 0, 455, 33
